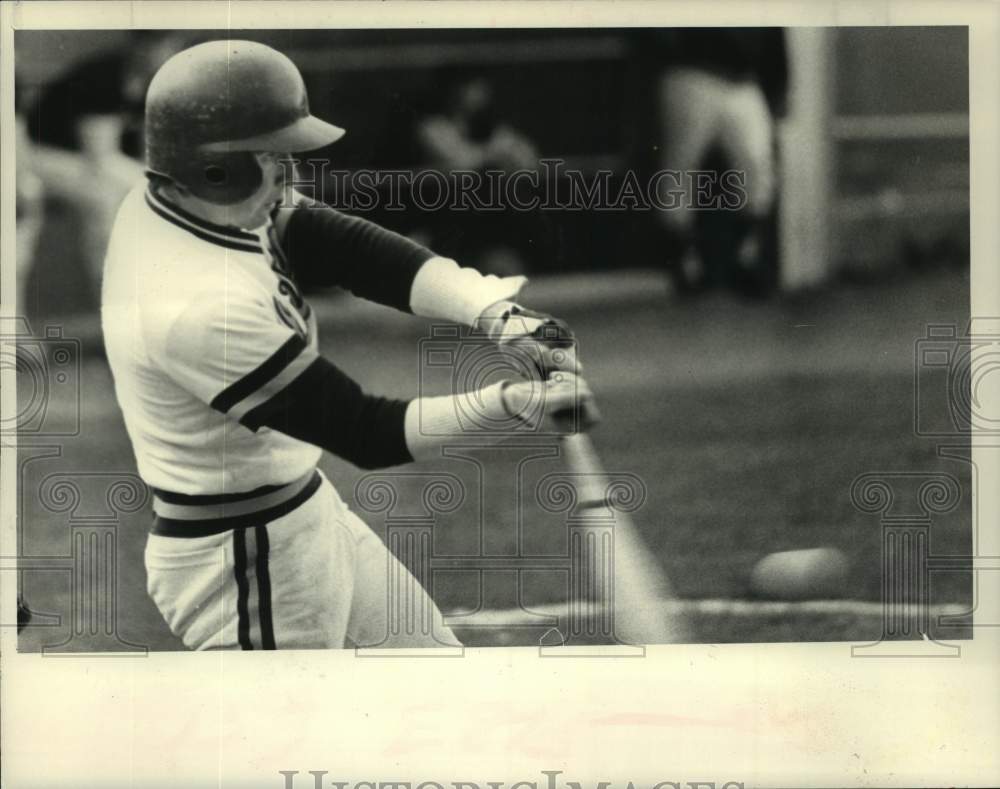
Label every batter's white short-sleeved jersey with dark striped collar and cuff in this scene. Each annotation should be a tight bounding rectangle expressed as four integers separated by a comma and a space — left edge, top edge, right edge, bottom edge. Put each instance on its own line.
101, 183, 321, 495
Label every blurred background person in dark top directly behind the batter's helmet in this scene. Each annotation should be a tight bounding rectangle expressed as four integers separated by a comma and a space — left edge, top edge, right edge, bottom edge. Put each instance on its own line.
27, 31, 185, 299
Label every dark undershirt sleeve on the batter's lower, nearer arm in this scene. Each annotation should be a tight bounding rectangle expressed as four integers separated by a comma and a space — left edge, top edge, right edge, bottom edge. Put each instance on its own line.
240, 357, 413, 469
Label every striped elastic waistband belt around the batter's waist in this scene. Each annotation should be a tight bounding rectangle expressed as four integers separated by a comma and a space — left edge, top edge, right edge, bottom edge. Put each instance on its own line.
153, 469, 323, 537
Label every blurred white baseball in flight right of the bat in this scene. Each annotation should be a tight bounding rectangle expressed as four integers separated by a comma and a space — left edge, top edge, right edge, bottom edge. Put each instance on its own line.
750, 548, 848, 600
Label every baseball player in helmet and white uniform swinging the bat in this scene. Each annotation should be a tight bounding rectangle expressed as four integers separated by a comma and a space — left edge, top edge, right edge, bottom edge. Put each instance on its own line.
102, 41, 591, 650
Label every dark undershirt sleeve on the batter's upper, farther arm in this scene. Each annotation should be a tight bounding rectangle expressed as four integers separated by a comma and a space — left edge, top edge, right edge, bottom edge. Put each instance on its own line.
281, 203, 434, 312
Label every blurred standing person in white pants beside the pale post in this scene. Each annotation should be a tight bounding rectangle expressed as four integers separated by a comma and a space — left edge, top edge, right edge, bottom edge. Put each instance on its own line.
636, 28, 788, 295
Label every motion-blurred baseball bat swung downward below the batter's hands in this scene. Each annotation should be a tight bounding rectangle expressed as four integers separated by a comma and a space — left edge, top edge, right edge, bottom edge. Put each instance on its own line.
560, 432, 690, 645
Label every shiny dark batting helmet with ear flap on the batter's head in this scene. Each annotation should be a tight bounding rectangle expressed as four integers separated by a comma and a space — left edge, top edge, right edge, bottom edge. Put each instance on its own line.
145, 41, 344, 205
